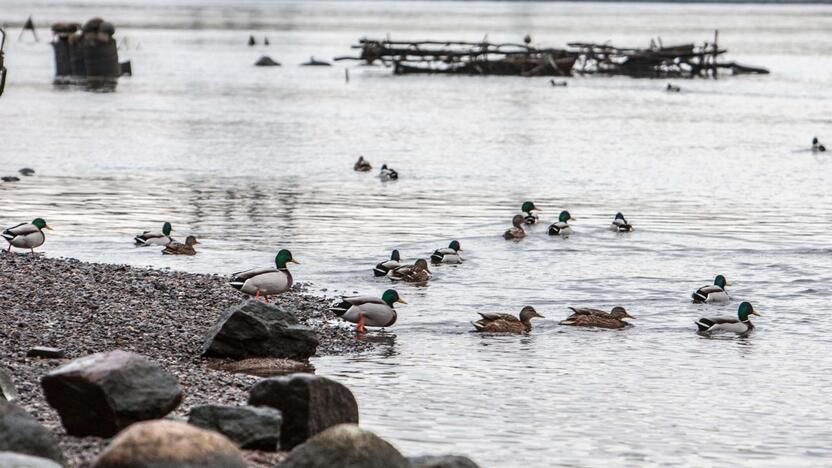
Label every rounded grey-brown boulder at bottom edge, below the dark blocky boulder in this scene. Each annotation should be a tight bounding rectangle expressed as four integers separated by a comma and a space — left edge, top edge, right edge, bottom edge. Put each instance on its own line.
280, 424, 411, 468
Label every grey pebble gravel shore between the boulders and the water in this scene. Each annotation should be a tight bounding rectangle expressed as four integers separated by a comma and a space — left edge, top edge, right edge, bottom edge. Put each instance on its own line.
0, 254, 372, 467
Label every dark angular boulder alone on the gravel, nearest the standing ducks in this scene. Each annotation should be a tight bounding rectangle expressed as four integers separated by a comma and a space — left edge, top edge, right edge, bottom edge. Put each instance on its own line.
202, 300, 318, 360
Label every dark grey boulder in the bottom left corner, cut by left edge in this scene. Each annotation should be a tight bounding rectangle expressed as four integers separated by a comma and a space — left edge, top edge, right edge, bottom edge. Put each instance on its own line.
0, 400, 64, 467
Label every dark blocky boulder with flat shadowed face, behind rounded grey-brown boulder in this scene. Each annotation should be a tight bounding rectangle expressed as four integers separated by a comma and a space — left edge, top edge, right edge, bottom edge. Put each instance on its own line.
248, 374, 358, 450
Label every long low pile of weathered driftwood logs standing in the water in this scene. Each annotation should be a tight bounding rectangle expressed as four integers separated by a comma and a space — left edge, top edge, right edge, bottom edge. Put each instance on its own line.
336, 33, 768, 78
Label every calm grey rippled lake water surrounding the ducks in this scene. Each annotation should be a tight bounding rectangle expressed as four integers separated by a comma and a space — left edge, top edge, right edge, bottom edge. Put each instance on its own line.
0, 0, 832, 467
